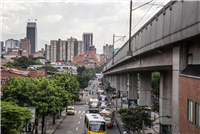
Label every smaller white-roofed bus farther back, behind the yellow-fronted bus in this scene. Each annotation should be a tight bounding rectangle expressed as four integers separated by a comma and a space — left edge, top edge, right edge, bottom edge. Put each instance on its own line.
89, 98, 99, 113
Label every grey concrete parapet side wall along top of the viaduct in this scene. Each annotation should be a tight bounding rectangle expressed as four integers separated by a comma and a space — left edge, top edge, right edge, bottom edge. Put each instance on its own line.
104, 0, 200, 70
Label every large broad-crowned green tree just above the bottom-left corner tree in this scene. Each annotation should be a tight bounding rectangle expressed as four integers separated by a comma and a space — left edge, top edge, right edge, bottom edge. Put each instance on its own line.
3, 77, 63, 132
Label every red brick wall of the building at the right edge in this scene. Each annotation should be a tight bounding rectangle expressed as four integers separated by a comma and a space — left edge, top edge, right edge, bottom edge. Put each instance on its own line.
180, 76, 200, 134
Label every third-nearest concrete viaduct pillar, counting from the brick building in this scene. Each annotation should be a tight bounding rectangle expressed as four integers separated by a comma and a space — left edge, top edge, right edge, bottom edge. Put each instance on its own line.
139, 72, 151, 107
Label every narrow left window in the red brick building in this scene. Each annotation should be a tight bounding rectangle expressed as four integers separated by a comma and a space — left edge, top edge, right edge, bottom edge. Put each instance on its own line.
187, 99, 193, 124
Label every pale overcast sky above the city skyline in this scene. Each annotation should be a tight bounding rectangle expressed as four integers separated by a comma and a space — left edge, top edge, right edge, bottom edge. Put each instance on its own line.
0, 0, 170, 53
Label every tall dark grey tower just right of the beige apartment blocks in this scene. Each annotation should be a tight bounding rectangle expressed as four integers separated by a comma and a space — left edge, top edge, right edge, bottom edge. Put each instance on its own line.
83, 33, 93, 52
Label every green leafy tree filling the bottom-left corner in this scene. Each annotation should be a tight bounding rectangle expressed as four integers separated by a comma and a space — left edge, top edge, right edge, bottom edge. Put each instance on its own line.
0, 101, 32, 134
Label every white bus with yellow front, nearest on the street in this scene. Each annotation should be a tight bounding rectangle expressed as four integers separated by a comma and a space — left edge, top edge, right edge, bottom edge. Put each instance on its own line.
84, 113, 107, 134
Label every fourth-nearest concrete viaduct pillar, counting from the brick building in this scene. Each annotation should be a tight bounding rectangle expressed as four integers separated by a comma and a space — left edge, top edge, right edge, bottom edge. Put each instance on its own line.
128, 73, 138, 100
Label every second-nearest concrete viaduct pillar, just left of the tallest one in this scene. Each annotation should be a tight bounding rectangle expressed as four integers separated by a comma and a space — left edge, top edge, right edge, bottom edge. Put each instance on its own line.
159, 71, 172, 126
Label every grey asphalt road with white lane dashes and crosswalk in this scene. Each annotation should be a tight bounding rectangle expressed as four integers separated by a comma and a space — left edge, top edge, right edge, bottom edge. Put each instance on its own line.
54, 80, 120, 134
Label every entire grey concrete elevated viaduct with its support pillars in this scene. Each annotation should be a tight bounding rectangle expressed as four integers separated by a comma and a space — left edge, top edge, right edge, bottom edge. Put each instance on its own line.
103, 0, 200, 134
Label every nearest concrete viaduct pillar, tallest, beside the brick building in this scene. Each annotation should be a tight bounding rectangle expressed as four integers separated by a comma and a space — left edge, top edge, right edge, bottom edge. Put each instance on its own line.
172, 43, 187, 134
